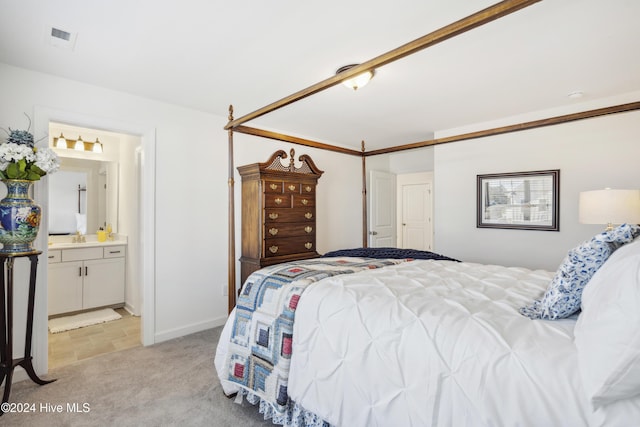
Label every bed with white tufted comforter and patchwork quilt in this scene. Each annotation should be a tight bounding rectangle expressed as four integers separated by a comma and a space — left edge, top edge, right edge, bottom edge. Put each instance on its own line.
215, 232, 640, 426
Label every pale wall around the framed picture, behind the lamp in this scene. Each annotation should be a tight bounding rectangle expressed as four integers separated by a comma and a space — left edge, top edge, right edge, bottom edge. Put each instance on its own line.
434, 112, 640, 271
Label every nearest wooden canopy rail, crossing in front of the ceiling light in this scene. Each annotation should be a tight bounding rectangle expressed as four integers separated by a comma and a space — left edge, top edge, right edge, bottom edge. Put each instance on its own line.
224, 0, 541, 130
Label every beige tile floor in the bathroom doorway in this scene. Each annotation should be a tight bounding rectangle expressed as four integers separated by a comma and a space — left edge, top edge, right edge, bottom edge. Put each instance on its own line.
49, 308, 141, 369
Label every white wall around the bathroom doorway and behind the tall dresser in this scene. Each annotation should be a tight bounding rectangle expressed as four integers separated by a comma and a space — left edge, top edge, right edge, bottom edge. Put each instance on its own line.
0, 63, 361, 371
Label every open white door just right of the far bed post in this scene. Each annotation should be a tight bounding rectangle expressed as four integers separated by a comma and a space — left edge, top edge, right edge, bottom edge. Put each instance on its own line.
367, 171, 397, 248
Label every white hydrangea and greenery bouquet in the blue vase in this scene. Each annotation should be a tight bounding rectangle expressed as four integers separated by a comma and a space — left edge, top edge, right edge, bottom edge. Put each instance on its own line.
0, 116, 60, 181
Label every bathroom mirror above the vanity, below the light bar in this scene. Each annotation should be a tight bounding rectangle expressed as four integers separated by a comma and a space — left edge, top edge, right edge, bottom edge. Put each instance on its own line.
48, 157, 118, 235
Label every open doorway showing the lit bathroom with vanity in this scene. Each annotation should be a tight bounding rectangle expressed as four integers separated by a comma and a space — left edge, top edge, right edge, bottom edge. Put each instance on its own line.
45, 121, 142, 368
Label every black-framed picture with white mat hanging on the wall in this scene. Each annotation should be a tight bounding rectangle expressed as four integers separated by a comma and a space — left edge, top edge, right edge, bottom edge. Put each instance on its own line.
477, 169, 560, 231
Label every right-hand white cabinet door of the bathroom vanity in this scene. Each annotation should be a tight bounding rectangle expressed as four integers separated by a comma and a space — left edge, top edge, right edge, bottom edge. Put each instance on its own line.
82, 258, 124, 309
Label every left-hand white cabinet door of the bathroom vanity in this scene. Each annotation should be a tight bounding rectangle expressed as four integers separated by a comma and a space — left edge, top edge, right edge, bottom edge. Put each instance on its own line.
47, 261, 84, 315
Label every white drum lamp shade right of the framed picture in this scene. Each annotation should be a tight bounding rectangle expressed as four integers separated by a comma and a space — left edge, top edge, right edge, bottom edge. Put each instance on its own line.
579, 189, 640, 224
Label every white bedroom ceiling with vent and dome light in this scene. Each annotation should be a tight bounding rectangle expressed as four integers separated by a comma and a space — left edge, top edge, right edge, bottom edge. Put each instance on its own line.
0, 0, 640, 150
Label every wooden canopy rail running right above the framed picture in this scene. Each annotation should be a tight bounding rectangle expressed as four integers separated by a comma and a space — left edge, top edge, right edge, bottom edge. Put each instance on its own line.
364, 102, 640, 156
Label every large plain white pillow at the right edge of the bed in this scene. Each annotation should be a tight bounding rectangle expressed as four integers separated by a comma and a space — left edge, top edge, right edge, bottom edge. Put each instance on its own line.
574, 237, 640, 408
